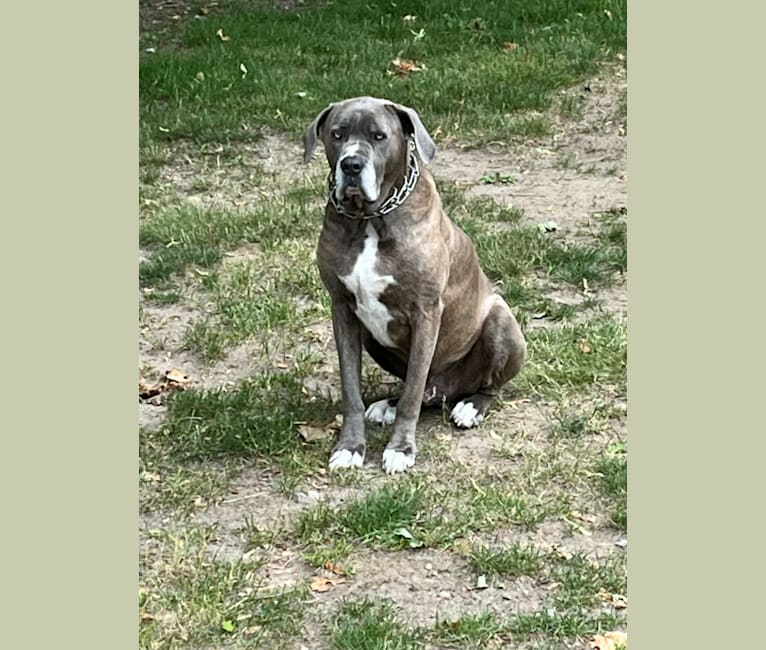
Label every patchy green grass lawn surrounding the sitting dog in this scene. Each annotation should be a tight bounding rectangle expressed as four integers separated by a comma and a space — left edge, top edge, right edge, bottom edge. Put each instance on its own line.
139, 0, 627, 650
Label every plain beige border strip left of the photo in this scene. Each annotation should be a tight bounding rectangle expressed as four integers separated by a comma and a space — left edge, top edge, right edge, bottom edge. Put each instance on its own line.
0, 1, 138, 650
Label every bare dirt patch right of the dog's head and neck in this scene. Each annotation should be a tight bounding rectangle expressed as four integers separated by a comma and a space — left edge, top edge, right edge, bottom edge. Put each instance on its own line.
432, 66, 628, 234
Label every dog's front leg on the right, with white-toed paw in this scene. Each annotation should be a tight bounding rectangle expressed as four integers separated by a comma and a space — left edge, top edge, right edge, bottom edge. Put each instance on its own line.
383, 302, 443, 474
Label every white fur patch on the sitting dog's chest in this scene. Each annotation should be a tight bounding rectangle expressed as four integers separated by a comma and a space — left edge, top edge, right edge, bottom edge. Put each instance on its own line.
340, 224, 394, 348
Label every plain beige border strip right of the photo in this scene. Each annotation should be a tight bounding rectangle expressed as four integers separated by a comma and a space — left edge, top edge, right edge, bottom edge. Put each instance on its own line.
628, 1, 766, 650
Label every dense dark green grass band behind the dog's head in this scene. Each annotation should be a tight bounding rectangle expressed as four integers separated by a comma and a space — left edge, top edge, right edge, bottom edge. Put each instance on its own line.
139, 0, 626, 145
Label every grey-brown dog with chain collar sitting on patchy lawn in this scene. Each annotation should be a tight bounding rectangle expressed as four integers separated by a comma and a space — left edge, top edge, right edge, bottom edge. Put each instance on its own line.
303, 97, 526, 474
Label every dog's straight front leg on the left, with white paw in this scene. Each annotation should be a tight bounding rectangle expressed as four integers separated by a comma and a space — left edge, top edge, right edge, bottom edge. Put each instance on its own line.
330, 301, 365, 470
